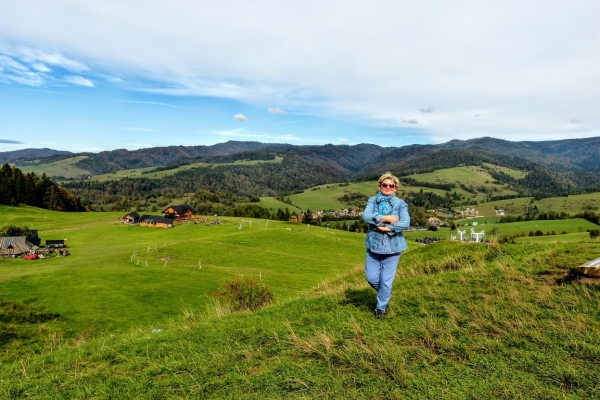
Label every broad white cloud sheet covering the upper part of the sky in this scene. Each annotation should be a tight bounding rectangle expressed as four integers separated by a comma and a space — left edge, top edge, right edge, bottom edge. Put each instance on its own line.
0, 0, 600, 142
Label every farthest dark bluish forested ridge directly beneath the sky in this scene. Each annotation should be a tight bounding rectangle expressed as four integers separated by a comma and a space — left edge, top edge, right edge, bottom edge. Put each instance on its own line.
5, 137, 600, 175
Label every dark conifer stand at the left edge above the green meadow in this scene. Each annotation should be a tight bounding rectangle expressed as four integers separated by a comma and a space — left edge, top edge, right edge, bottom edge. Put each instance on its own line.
0, 164, 86, 211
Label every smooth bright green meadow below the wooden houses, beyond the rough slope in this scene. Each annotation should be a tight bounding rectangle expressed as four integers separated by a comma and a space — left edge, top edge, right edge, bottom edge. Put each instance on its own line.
0, 206, 364, 332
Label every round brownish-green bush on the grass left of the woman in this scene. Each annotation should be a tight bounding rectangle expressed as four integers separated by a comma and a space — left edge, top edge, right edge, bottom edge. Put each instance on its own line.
215, 277, 273, 311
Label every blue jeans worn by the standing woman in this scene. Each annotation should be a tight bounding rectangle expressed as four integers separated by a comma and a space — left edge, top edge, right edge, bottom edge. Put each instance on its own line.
365, 250, 402, 311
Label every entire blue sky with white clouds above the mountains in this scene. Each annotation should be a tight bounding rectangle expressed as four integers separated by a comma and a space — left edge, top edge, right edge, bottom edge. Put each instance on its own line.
0, 0, 600, 152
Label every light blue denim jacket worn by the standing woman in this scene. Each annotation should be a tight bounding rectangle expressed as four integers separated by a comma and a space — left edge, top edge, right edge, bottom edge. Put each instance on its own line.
363, 196, 410, 253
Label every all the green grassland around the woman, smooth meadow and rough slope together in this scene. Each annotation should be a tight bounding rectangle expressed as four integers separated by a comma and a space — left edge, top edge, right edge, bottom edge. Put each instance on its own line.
0, 207, 600, 399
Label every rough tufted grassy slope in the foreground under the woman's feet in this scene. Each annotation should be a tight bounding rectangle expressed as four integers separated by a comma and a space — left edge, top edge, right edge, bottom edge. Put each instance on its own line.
0, 236, 600, 399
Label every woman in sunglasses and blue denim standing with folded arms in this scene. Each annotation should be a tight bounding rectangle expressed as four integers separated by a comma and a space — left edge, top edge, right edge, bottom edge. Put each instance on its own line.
363, 172, 410, 318
